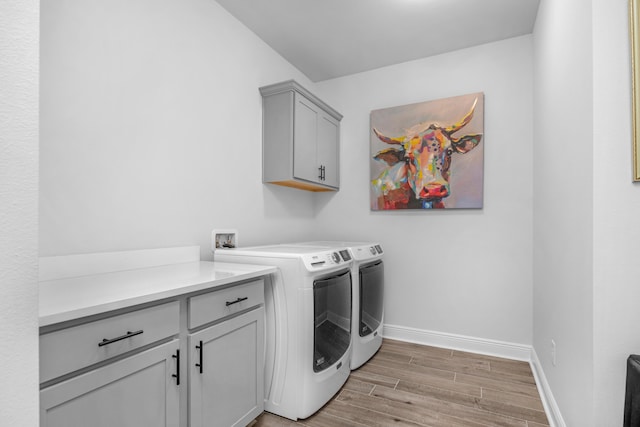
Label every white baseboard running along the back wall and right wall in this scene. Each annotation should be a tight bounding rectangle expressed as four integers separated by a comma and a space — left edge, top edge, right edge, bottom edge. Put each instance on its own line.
382, 325, 566, 427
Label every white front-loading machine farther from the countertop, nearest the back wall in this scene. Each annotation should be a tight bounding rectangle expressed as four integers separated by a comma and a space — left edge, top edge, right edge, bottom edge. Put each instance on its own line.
296, 241, 384, 370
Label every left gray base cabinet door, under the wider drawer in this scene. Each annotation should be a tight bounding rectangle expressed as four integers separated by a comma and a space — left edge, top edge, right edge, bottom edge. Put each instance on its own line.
40, 340, 180, 427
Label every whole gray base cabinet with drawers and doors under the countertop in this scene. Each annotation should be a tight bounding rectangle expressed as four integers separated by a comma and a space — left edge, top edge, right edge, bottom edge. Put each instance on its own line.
40, 280, 265, 427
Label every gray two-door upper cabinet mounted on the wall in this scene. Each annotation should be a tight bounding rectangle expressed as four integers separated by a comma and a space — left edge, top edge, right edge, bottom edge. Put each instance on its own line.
260, 80, 342, 191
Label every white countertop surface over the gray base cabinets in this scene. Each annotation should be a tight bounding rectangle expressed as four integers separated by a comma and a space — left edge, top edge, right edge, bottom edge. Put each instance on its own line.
39, 261, 277, 326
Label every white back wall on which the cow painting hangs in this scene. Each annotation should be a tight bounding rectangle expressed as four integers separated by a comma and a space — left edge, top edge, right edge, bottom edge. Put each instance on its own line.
316, 36, 533, 344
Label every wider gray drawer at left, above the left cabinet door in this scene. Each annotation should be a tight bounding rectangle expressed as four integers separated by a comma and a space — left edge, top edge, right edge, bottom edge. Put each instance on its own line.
40, 301, 180, 383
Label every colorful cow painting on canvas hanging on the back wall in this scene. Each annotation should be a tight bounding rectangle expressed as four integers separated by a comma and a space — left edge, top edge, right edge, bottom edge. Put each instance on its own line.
371, 93, 484, 210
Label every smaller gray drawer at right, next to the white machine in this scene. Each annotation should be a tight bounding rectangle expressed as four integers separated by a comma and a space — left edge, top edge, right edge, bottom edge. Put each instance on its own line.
189, 279, 264, 329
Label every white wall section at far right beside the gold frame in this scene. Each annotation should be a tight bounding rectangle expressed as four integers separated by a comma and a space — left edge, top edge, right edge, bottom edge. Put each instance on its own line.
593, 0, 640, 426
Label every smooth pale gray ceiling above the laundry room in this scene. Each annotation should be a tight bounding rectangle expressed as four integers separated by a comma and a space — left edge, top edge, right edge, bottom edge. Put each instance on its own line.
216, 0, 539, 82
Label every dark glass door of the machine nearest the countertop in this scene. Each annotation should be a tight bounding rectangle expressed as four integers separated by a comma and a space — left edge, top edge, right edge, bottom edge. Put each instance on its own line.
313, 270, 351, 372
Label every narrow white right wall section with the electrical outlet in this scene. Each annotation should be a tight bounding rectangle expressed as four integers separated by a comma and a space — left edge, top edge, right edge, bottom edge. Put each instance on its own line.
533, 0, 596, 427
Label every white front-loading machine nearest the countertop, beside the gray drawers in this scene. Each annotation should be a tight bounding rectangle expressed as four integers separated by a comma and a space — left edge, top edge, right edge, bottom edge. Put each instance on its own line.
214, 245, 353, 420
